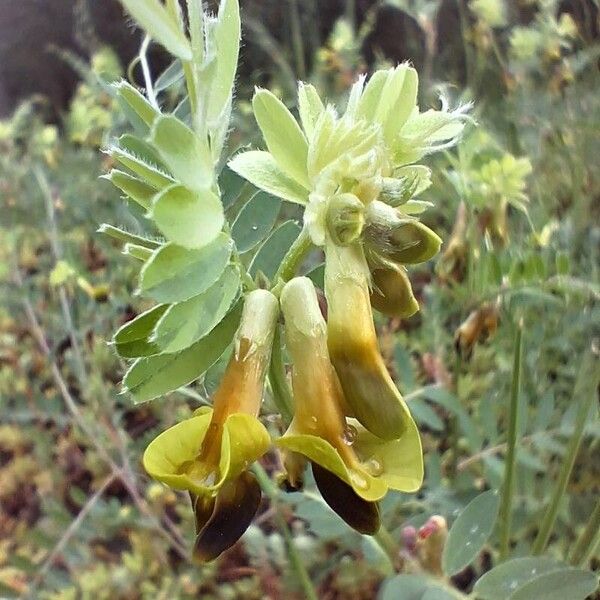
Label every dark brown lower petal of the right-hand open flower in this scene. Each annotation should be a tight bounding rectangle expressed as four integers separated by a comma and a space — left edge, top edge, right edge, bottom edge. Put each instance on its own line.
311, 462, 381, 535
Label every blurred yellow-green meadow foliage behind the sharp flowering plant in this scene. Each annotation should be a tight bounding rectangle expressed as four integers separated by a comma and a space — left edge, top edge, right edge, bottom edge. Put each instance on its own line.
0, 0, 600, 600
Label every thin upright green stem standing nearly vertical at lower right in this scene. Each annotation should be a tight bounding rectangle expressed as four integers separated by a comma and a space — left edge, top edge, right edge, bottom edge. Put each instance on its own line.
499, 323, 523, 560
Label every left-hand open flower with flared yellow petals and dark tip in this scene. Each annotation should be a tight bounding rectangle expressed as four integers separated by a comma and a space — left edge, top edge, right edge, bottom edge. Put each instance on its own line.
143, 290, 279, 562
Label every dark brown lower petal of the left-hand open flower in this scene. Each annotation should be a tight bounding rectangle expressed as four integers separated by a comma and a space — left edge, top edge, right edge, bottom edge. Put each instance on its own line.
194, 471, 261, 563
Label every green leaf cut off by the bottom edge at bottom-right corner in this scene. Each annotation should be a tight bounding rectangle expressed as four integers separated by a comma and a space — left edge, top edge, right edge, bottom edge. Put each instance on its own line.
508, 569, 598, 600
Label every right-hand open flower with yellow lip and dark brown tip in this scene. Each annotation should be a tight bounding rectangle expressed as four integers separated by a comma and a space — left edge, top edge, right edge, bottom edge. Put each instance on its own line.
276, 277, 423, 533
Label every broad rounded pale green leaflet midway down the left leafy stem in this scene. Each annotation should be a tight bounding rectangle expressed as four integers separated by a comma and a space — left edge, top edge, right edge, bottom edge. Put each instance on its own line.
152, 185, 225, 248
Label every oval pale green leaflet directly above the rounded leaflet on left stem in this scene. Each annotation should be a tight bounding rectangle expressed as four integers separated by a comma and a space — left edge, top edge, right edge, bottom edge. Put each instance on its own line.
150, 115, 213, 190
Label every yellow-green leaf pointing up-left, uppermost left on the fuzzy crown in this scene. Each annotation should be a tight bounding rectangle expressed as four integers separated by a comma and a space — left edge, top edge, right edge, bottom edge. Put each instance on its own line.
252, 90, 310, 189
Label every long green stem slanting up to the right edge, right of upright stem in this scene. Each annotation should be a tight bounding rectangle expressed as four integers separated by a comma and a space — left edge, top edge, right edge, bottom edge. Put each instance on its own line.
532, 351, 600, 555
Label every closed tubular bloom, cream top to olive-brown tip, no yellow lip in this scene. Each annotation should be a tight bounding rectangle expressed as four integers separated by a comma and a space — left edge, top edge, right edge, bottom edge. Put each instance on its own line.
325, 243, 412, 440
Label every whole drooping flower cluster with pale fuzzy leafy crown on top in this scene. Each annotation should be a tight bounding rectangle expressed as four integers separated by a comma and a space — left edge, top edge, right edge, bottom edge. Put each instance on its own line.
144, 65, 468, 561
